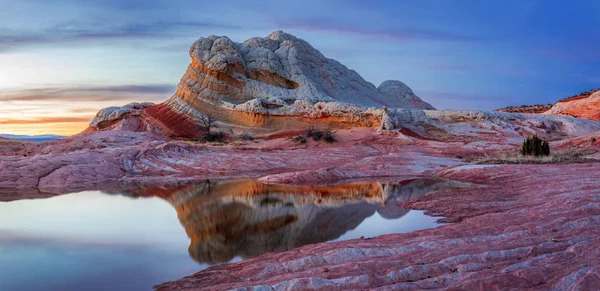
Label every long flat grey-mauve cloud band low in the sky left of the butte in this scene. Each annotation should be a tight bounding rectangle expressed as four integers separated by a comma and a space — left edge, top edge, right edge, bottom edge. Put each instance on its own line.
0, 84, 177, 101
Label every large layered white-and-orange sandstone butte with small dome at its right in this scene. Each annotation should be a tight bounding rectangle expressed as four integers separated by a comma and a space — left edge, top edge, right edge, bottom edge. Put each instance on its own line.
89, 31, 434, 136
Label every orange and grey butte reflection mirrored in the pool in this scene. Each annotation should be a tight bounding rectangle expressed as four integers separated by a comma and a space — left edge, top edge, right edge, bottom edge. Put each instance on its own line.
111, 179, 464, 264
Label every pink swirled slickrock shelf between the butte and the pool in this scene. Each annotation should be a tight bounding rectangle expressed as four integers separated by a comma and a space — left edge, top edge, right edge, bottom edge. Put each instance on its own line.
0, 128, 462, 200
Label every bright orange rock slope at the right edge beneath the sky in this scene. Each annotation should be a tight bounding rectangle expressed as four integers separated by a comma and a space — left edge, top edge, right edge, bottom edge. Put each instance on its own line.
545, 91, 600, 120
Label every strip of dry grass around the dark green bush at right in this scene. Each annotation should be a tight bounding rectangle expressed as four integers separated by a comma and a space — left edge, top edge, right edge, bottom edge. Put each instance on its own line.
468, 150, 600, 165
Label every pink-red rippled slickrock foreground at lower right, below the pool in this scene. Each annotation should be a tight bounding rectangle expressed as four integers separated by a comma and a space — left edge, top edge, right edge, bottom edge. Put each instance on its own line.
157, 164, 600, 290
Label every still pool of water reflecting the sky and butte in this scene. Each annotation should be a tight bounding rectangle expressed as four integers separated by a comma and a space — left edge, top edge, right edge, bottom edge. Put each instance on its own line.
0, 180, 462, 291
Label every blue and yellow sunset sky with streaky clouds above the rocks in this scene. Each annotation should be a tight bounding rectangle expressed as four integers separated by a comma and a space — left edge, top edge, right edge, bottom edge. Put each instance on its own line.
0, 0, 600, 135
